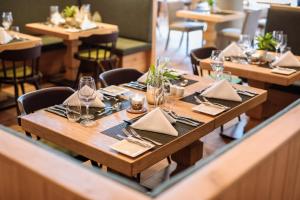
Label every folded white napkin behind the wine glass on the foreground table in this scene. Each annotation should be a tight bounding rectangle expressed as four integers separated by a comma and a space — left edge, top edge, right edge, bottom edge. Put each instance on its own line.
63, 86, 105, 108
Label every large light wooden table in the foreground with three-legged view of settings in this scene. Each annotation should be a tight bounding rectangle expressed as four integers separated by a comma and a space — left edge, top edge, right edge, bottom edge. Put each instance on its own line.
22, 76, 267, 176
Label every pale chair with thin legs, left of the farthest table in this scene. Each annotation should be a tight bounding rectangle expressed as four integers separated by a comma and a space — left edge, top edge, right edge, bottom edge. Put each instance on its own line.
165, 1, 204, 55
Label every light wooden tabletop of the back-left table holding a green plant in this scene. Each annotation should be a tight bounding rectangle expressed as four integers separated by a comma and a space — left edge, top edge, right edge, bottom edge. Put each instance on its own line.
26, 23, 118, 40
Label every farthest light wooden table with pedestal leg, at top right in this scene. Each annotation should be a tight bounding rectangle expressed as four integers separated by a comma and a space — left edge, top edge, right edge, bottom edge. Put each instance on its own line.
176, 10, 244, 46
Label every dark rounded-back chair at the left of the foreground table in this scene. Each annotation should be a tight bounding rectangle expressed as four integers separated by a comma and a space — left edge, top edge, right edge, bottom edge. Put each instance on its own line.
18, 87, 98, 166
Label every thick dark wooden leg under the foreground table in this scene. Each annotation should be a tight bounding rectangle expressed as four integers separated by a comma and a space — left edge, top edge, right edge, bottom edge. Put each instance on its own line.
171, 140, 203, 175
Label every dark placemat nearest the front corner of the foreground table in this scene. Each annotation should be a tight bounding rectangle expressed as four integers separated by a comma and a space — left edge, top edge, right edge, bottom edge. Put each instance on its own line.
102, 115, 204, 147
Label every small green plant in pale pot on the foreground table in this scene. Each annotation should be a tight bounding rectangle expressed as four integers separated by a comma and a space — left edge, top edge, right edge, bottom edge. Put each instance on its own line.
146, 62, 179, 106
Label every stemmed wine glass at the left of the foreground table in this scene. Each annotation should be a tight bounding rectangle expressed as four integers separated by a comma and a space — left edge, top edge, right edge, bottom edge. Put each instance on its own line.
78, 76, 97, 126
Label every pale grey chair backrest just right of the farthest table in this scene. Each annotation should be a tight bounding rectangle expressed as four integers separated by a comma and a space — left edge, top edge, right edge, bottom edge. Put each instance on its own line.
242, 9, 262, 40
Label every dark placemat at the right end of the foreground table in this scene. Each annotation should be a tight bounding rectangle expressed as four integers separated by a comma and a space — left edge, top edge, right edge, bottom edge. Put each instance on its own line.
180, 93, 253, 109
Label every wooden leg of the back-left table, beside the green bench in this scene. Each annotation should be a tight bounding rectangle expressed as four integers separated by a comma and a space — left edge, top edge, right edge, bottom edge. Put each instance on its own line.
64, 40, 80, 80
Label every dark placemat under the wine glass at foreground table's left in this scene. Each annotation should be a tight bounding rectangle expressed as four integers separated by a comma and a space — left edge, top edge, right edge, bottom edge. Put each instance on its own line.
45, 100, 130, 123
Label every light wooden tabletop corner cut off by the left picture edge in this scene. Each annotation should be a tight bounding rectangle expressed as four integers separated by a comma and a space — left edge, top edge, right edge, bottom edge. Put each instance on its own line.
0, 31, 42, 52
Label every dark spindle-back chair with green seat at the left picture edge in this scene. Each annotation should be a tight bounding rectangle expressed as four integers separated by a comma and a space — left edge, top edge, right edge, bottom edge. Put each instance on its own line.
0, 46, 42, 114
